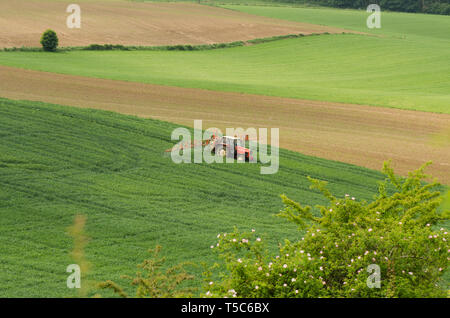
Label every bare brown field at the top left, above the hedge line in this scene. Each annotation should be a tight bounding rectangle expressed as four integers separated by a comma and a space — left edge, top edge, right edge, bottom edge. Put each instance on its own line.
0, 0, 344, 48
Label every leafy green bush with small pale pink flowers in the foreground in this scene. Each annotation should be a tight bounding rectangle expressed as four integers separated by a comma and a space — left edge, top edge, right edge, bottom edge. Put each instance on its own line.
202, 163, 450, 297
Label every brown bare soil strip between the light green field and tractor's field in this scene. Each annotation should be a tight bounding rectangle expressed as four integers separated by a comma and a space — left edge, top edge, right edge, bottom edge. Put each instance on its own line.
0, 66, 450, 184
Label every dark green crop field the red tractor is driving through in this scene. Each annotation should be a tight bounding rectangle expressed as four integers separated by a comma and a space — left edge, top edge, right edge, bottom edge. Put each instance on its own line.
0, 99, 394, 297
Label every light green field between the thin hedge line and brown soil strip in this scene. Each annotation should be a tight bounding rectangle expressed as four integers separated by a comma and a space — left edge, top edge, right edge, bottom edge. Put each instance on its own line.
0, 29, 450, 113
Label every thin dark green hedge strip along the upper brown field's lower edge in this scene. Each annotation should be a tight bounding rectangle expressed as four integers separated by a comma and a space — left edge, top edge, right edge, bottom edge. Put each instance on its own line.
3, 32, 338, 52
